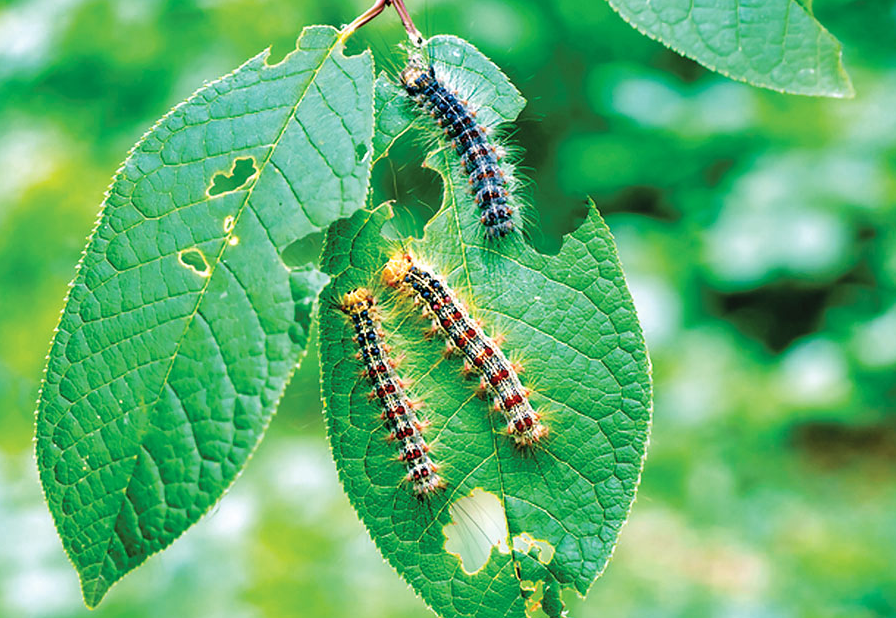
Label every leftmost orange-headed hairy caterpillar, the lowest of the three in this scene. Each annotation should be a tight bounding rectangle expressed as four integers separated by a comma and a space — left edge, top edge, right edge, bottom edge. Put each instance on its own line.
340, 288, 444, 501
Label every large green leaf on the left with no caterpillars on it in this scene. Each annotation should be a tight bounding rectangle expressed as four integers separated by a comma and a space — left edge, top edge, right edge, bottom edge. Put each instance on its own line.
36, 27, 373, 607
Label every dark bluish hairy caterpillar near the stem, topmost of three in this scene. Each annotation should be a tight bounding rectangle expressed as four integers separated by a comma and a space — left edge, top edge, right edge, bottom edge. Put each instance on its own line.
400, 55, 516, 239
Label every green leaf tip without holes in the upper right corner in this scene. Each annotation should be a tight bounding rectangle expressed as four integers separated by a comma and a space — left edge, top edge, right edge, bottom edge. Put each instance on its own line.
607, 0, 855, 98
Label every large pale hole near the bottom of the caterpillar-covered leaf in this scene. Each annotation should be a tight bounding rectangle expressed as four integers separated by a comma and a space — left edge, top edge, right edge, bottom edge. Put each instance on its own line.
442, 488, 510, 575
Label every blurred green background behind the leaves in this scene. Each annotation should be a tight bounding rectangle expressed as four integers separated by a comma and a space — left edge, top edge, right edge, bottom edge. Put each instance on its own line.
0, 0, 896, 618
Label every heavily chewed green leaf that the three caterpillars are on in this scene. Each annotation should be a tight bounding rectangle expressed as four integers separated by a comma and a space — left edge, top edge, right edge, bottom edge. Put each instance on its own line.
320, 40, 651, 618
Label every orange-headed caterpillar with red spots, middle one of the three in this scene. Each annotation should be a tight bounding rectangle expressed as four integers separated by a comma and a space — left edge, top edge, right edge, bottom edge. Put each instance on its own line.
382, 253, 548, 448
